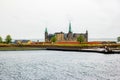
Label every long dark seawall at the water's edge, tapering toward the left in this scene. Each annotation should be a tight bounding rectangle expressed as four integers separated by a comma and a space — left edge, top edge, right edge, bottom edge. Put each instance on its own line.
46, 47, 120, 54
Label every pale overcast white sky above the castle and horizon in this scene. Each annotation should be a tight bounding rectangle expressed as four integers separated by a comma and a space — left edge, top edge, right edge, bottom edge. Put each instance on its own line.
0, 0, 120, 39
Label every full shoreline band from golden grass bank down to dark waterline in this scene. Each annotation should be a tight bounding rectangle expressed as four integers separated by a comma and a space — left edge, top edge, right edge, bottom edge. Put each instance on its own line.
0, 44, 120, 54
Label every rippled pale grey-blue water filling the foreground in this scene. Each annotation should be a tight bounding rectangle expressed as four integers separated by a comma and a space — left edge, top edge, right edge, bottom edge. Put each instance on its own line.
0, 50, 120, 80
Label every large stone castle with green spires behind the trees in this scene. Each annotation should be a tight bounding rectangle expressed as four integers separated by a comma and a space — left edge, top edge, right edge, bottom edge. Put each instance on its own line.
45, 23, 88, 42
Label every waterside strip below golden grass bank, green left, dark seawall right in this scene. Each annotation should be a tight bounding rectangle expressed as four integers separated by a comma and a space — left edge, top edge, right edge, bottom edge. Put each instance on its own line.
0, 46, 120, 54
